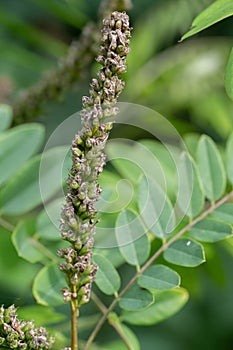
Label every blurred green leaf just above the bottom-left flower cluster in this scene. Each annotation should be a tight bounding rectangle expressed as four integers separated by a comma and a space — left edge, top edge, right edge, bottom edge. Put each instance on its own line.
17, 305, 66, 327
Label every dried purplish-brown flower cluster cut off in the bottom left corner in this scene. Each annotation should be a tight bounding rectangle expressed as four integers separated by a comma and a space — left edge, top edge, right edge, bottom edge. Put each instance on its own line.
0, 305, 54, 350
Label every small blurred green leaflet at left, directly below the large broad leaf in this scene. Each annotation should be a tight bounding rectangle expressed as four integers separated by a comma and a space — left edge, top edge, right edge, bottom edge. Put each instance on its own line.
12, 219, 44, 263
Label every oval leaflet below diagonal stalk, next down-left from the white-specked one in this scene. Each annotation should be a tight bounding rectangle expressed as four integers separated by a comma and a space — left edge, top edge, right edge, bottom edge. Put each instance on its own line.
138, 264, 180, 290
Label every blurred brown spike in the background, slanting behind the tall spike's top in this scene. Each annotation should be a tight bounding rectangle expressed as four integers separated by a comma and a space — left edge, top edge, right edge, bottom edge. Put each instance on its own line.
13, 0, 133, 125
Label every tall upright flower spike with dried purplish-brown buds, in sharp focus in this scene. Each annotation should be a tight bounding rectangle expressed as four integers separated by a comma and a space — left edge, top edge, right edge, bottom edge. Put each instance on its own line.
58, 12, 131, 308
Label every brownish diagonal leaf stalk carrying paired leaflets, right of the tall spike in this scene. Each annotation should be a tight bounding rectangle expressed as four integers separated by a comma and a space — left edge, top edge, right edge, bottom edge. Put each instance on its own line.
84, 191, 233, 350
